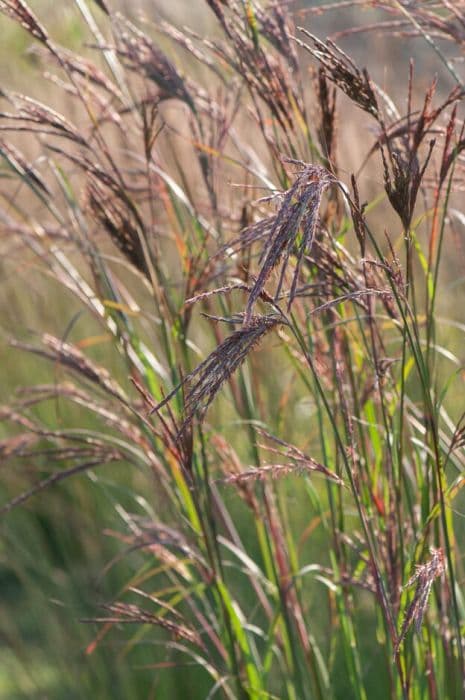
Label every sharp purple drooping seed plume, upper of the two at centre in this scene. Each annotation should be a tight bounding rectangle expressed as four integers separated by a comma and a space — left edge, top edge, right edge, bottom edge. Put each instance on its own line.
244, 159, 336, 324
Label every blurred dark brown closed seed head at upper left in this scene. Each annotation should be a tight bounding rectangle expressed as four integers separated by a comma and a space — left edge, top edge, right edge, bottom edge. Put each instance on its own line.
86, 175, 150, 278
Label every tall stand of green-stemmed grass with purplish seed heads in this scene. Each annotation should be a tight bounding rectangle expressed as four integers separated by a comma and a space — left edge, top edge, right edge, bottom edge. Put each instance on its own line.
0, 0, 465, 700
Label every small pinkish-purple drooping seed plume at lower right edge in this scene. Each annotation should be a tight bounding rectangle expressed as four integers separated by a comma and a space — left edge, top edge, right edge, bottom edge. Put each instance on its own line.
395, 549, 445, 654
